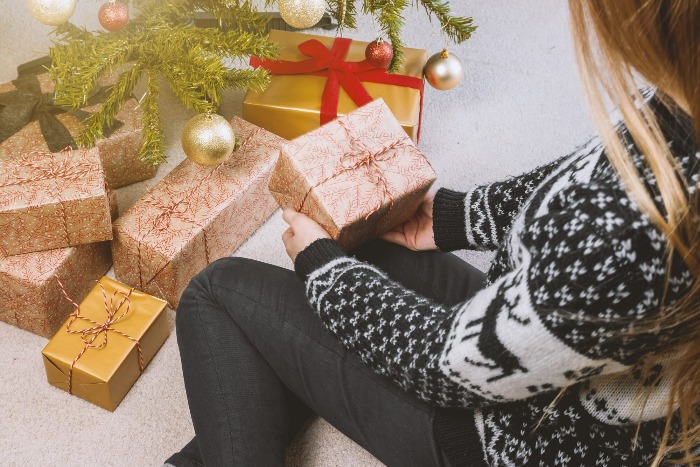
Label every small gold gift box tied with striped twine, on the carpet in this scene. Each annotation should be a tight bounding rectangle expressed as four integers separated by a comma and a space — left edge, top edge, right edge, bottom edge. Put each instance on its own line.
42, 277, 170, 411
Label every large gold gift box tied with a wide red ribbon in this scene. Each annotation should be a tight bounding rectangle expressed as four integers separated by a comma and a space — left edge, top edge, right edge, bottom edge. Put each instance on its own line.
243, 30, 428, 141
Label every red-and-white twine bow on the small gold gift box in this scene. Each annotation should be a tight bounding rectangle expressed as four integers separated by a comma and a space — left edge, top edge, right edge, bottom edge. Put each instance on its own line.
54, 274, 145, 394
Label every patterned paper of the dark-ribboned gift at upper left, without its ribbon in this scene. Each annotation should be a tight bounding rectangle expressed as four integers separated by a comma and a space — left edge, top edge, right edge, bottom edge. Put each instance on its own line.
0, 73, 156, 188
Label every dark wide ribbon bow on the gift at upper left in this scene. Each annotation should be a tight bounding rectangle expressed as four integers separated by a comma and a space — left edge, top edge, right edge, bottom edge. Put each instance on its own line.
0, 75, 123, 152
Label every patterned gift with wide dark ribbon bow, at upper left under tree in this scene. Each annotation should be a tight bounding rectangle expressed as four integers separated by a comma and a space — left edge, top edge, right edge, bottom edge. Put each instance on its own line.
0, 73, 156, 188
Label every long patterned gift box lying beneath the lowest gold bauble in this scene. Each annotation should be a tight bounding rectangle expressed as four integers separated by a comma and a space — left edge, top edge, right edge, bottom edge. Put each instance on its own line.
113, 118, 286, 309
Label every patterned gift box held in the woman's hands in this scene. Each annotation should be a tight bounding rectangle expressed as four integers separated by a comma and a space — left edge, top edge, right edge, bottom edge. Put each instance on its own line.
270, 99, 435, 250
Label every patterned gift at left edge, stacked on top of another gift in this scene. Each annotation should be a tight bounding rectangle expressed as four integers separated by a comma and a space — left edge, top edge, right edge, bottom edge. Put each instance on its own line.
0, 148, 112, 256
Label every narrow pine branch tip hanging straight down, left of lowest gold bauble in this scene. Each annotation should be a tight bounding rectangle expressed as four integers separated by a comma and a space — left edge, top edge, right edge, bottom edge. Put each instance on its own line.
139, 69, 166, 167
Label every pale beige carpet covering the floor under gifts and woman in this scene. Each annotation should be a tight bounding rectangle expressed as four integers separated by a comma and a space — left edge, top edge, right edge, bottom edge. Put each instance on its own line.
0, 0, 593, 466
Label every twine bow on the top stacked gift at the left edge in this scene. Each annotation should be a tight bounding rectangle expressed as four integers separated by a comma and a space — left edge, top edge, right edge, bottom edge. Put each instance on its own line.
0, 146, 93, 244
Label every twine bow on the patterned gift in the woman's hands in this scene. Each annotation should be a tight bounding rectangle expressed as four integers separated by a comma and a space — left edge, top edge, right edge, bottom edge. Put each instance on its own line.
297, 120, 406, 220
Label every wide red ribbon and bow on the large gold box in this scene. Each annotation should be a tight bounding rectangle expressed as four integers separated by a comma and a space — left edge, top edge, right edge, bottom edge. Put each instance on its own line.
250, 37, 423, 140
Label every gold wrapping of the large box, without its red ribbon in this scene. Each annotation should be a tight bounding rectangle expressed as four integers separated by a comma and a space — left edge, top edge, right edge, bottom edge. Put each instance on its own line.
243, 30, 428, 142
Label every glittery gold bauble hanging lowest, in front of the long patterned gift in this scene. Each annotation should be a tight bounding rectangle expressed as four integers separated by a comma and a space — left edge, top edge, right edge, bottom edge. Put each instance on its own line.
182, 113, 236, 165
